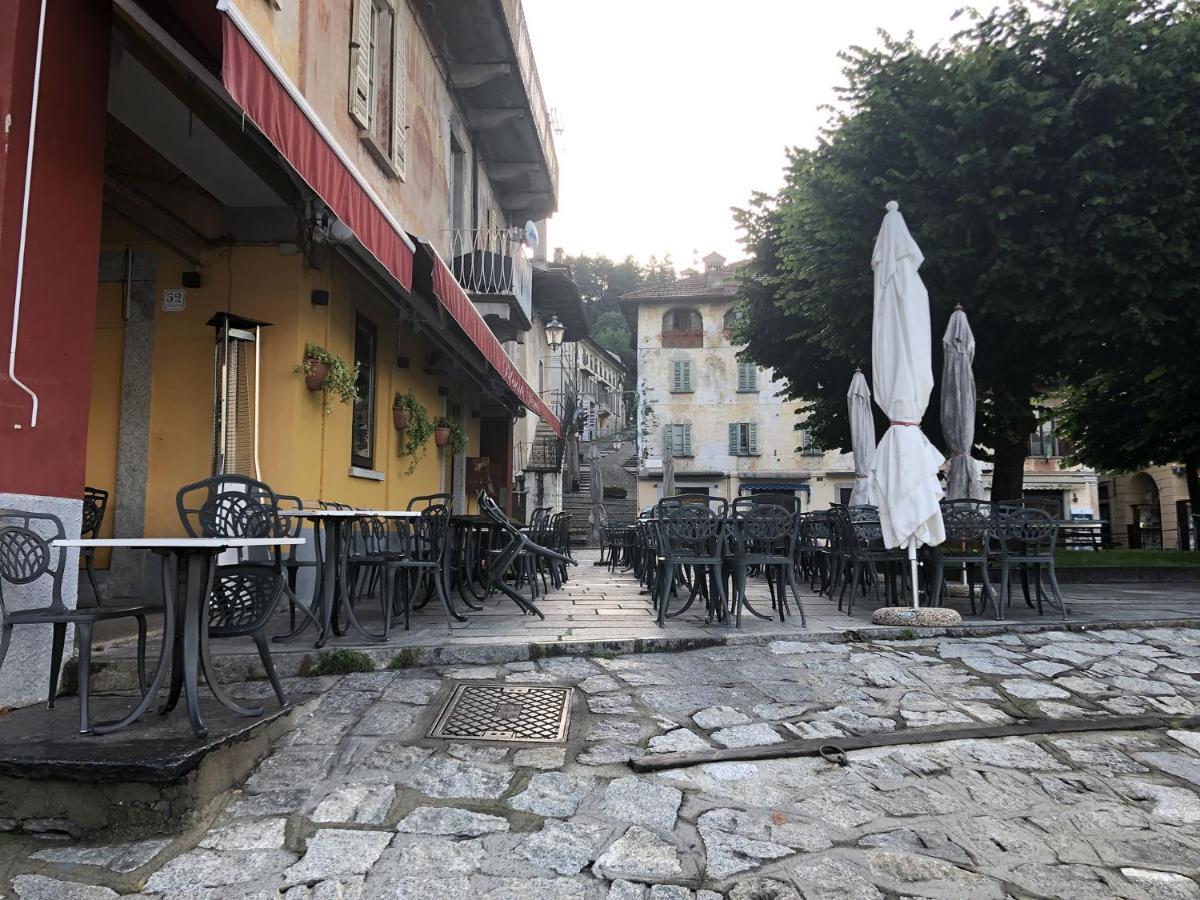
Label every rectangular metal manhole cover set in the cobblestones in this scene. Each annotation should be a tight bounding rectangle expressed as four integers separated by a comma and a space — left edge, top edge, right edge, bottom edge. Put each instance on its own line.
430, 684, 575, 744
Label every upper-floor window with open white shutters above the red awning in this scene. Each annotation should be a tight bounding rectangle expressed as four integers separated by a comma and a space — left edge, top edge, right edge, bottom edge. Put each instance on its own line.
349, 0, 408, 178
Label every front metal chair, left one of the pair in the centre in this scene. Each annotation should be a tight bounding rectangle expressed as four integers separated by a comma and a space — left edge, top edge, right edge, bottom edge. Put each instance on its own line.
656, 504, 728, 626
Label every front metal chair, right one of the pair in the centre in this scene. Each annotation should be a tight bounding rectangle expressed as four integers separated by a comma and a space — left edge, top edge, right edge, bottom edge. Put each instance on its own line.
728, 497, 808, 626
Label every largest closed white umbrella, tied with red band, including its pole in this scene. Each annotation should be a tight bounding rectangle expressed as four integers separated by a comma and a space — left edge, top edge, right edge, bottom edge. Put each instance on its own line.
871, 200, 946, 606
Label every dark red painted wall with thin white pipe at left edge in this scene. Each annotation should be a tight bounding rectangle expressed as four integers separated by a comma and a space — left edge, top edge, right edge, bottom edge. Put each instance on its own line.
0, 0, 112, 497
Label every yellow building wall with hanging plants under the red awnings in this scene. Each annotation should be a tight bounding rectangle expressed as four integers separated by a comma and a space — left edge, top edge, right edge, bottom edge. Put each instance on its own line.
89, 235, 480, 535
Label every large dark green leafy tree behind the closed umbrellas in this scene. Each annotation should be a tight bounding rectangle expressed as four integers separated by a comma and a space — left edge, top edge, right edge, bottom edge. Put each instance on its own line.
737, 0, 1200, 498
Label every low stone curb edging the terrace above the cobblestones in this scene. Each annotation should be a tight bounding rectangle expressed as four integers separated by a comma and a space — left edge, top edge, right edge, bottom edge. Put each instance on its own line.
84, 619, 1200, 692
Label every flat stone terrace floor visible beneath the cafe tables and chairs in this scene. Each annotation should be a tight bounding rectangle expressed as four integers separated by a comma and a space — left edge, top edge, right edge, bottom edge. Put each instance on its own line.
87, 550, 1200, 689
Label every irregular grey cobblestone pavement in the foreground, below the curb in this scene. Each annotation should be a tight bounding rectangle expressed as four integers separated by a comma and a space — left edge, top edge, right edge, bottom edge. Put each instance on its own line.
0, 628, 1200, 900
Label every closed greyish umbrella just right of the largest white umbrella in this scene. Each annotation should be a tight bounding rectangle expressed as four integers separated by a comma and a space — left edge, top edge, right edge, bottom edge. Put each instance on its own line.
942, 305, 984, 500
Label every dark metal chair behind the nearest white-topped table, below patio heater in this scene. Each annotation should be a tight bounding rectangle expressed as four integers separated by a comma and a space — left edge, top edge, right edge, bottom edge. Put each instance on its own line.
175, 475, 288, 709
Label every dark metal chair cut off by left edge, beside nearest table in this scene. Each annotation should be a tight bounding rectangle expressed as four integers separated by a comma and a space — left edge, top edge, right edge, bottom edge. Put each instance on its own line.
0, 509, 148, 734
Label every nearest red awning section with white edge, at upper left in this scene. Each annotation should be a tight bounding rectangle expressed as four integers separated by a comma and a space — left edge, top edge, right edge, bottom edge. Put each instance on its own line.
221, 13, 413, 289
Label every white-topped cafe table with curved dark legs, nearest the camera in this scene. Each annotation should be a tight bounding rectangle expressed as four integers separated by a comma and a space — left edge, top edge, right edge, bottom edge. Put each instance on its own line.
54, 538, 305, 738
